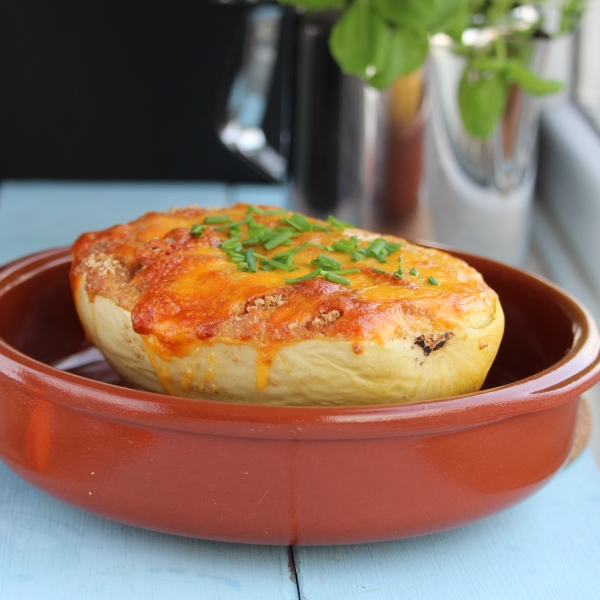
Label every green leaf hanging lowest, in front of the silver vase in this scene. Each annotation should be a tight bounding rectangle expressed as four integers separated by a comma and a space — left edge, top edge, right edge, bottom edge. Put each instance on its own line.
458, 67, 507, 139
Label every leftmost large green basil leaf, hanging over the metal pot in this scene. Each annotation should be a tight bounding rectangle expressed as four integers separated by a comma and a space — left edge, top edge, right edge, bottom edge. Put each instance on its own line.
329, 0, 388, 78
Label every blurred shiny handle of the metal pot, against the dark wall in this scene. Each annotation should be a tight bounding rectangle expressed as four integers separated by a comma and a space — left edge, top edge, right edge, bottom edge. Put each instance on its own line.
218, 5, 288, 182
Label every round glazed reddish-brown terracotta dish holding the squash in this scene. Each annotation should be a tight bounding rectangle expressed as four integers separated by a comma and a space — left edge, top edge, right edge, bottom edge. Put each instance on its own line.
0, 250, 600, 544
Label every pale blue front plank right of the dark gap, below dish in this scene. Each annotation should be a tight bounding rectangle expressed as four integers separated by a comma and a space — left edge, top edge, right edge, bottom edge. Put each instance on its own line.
294, 451, 600, 600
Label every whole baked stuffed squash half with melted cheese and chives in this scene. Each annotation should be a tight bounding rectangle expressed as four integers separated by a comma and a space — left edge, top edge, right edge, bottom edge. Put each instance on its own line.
71, 204, 504, 405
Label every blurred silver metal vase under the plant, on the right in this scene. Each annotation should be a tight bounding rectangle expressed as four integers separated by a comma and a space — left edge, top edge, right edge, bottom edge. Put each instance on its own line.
425, 21, 551, 265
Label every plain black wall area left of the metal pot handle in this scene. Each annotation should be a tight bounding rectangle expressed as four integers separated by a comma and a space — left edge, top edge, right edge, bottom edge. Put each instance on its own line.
0, 0, 274, 182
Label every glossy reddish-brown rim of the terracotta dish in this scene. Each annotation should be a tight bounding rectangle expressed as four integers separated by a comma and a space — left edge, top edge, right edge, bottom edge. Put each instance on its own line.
0, 244, 600, 439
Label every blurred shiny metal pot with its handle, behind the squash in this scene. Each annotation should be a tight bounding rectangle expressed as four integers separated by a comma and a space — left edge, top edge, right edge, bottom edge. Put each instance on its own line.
220, 6, 423, 228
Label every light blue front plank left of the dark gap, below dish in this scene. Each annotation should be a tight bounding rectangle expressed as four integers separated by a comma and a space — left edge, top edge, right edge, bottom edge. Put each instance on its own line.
0, 463, 298, 600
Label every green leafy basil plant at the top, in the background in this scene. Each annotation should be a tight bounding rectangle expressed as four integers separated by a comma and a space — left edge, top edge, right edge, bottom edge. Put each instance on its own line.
279, 0, 586, 139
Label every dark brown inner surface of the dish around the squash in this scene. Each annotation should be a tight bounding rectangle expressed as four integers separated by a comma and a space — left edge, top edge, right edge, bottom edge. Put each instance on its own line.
0, 255, 577, 396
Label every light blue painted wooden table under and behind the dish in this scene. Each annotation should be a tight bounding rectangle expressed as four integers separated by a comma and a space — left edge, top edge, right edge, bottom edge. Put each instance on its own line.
0, 182, 600, 600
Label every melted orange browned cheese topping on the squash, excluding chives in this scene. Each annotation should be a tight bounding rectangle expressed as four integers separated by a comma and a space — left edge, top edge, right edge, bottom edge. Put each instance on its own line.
72, 205, 495, 366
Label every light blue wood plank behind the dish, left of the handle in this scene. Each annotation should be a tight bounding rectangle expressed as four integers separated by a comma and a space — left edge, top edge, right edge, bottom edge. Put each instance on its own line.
0, 181, 227, 264
